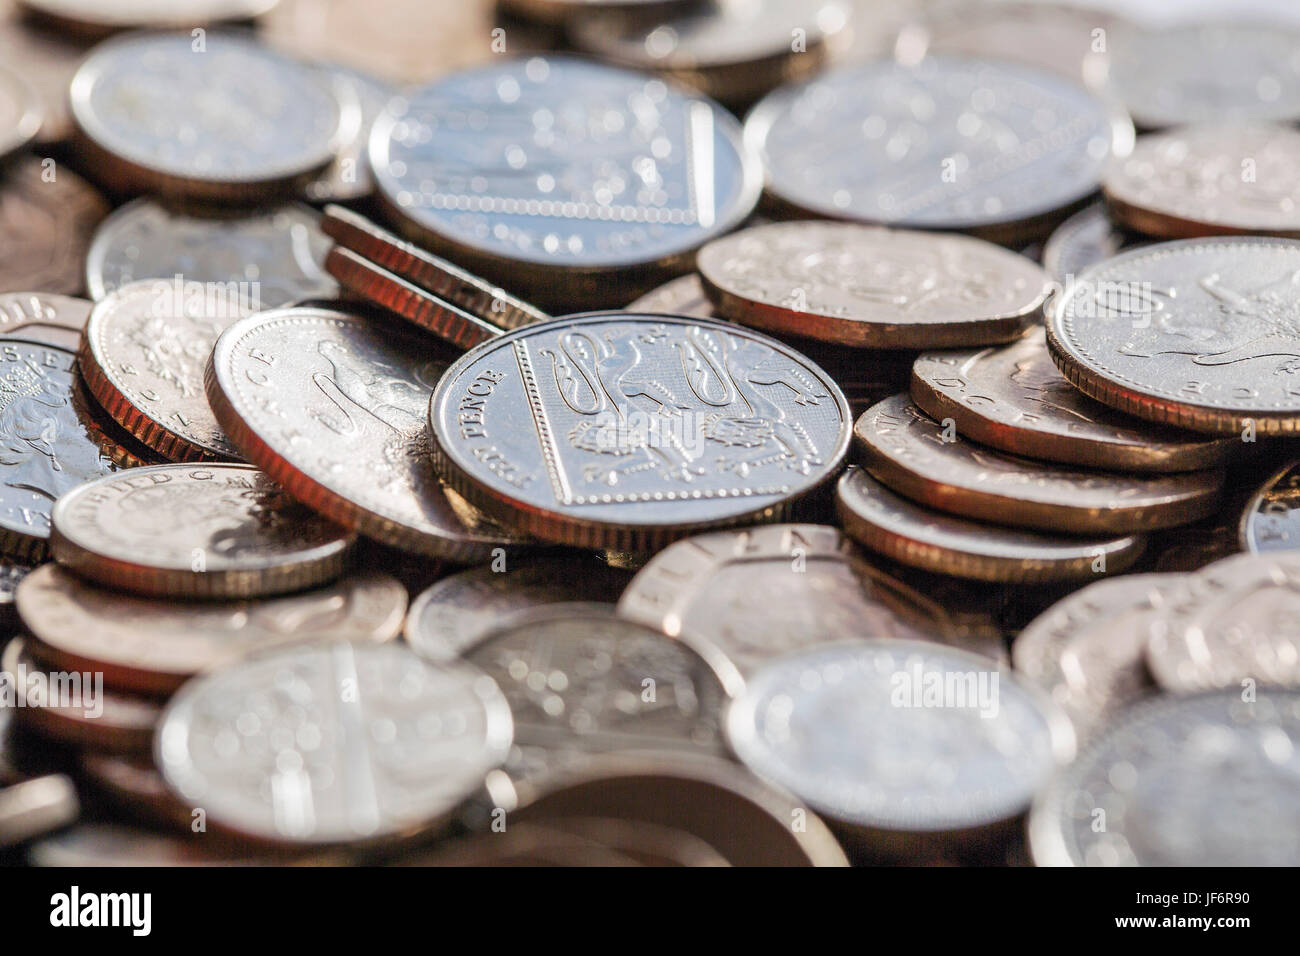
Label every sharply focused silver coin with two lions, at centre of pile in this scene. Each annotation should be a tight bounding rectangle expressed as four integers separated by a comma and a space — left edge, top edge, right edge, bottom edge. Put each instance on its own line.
429, 312, 849, 551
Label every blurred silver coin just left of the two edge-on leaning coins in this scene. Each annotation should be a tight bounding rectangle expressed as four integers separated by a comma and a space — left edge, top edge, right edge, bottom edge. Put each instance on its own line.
86, 199, 338, 308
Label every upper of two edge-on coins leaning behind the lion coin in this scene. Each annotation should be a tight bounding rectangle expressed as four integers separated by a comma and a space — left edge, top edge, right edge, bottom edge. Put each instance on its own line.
321, 206, 551, 329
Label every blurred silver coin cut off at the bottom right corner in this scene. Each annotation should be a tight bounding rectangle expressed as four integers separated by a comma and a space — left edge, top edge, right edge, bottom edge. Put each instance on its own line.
1030, 689, 1300, 866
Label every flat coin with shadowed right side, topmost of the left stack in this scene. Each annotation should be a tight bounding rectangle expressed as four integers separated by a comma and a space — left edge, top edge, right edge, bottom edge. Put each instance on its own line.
51, 464, 355, 598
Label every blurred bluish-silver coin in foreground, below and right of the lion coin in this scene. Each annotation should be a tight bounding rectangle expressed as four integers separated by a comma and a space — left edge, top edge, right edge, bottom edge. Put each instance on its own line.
727, 640, 1074, 856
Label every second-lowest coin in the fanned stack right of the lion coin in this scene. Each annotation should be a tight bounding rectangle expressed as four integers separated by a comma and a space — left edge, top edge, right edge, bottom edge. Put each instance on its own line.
853, 395, 1223, 536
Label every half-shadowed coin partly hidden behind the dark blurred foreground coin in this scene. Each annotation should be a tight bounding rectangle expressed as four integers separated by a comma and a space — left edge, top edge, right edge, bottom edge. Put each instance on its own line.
404, 555, 632, 661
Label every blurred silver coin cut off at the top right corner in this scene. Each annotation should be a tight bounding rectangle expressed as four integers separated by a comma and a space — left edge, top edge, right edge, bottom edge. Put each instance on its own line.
1110, 20, 1300, 129
